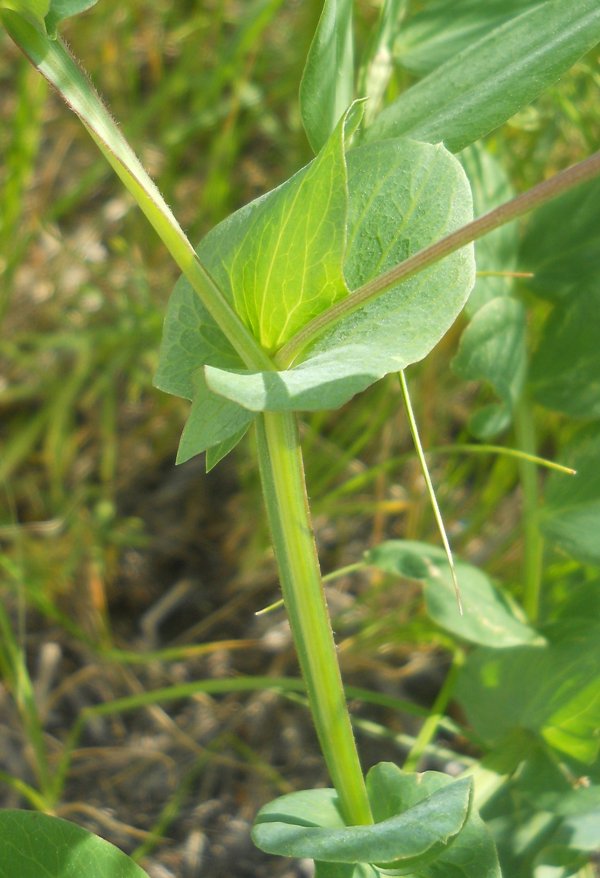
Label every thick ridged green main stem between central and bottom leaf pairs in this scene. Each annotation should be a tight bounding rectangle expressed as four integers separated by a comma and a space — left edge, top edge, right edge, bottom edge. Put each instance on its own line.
257, 412, 373, 825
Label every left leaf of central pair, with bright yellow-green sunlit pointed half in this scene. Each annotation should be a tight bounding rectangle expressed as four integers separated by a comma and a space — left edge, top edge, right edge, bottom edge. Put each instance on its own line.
155, 114, 357, 462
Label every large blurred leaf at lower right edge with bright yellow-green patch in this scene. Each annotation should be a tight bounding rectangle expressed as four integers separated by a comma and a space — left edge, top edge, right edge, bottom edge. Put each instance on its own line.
456, 619, 600, 762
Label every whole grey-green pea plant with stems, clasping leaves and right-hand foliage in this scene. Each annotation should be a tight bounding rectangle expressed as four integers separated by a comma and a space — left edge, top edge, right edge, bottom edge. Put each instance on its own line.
0, 0, 600, 878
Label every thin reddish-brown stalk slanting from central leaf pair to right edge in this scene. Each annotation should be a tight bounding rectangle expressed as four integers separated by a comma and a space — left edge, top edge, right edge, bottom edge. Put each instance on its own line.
275, 152, 600, 369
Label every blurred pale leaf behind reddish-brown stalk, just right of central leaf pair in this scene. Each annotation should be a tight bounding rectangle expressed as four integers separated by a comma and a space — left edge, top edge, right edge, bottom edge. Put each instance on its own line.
458, 141, 519, 316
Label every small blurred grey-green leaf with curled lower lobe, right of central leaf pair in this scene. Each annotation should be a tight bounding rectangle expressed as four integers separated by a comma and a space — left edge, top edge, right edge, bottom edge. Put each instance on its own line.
452, 296, 527, 439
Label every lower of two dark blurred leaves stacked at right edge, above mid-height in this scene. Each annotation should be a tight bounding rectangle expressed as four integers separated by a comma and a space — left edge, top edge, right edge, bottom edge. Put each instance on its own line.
529, 284, 600, 418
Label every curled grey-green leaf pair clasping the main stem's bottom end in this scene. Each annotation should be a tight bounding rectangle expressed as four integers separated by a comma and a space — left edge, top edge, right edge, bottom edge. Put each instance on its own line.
253, 762, 500, 878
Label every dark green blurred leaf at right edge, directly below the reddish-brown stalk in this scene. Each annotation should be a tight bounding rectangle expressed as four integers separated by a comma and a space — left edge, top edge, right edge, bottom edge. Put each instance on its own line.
519, 180, 600, 301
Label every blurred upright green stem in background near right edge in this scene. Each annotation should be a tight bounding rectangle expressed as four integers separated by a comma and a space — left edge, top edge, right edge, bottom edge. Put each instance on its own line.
515, 398, 543, 623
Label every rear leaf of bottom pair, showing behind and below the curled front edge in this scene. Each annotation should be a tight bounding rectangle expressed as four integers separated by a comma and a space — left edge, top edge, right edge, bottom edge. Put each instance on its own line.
367, 762, 501, 878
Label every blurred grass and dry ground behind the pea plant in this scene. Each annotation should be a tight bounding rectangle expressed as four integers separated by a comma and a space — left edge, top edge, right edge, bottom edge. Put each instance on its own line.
0, 0, 600, 878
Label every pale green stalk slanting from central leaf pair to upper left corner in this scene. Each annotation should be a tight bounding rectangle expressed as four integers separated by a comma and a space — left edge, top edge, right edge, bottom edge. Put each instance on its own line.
0, 9, 273, 370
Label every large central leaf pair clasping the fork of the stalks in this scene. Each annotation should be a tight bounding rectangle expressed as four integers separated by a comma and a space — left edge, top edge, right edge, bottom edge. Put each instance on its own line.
156, 117, 474, 470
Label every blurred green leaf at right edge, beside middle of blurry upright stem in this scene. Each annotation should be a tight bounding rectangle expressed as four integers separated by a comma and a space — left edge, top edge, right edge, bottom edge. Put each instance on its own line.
541, 424, 600, 564
